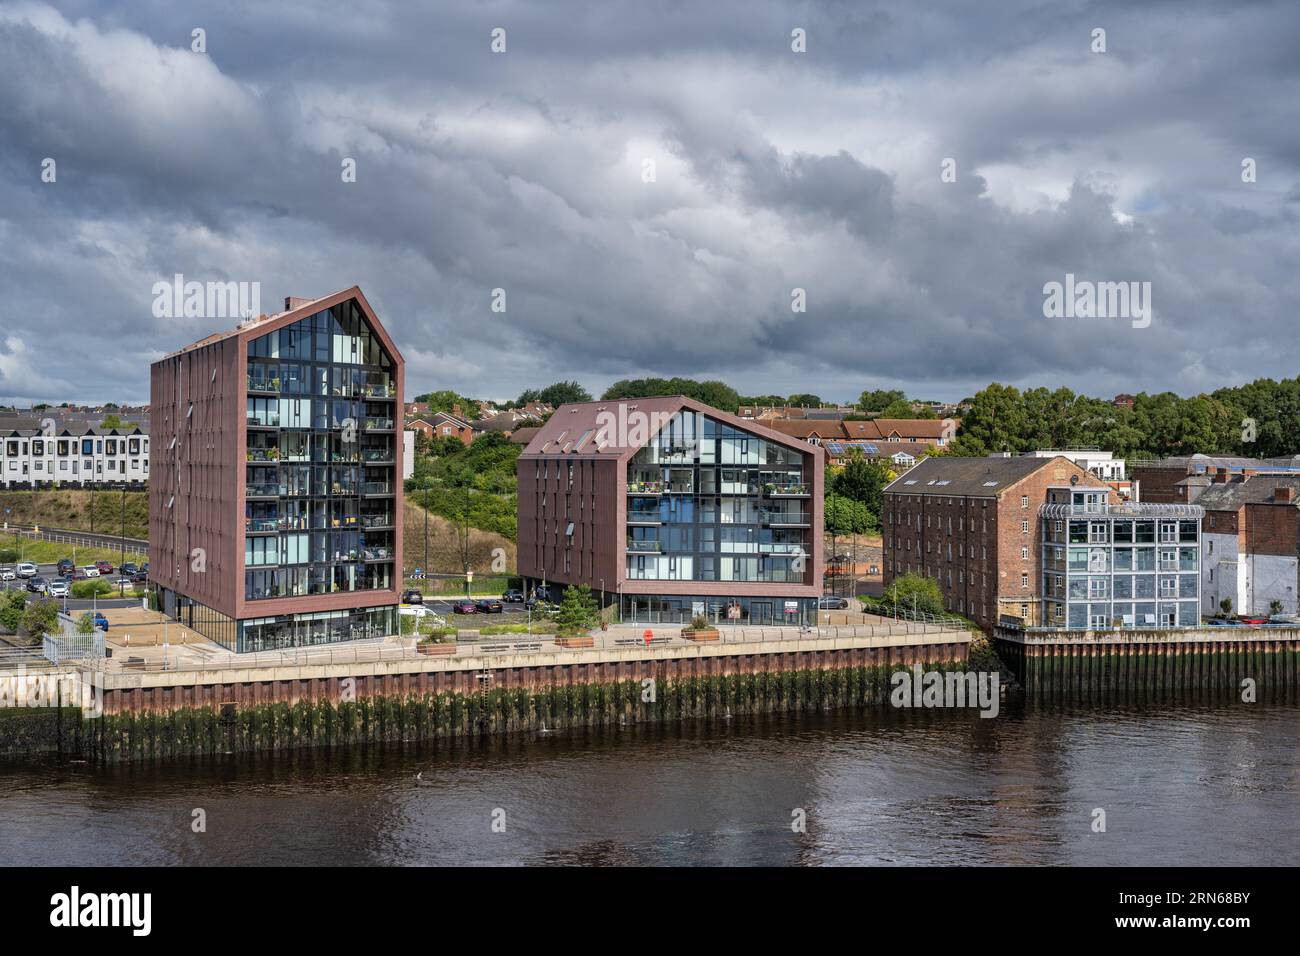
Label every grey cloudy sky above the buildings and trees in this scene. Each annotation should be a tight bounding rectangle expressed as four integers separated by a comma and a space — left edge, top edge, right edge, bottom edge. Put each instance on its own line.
0, 0, 1300, 403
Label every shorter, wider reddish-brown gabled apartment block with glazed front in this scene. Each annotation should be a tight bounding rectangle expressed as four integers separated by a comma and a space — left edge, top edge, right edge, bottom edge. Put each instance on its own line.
516, 395, 824, 624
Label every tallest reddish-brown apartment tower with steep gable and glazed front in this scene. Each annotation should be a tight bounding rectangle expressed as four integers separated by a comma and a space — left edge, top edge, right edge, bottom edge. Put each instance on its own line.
150, 286, 403, 652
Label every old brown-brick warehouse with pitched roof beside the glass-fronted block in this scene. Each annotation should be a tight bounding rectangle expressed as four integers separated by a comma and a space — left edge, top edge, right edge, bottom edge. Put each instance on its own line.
880, 457, 1110, 630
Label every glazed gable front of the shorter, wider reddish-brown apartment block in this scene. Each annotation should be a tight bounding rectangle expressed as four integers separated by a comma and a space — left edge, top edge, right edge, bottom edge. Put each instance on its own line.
625, 411, 813, 587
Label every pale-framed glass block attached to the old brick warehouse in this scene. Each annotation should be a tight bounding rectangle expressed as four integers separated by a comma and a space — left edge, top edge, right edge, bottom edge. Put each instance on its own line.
1041, 493, 1204, 630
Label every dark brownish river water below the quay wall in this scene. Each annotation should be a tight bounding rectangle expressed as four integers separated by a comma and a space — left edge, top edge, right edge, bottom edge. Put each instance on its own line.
0, 700, 1300, 865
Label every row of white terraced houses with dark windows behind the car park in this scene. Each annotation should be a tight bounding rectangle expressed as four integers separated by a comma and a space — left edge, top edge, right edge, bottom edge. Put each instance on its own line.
0, 424, 150, 488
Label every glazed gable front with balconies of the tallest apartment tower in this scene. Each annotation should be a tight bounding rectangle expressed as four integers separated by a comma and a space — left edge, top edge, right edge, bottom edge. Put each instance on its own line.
244, 300, 399, 601
